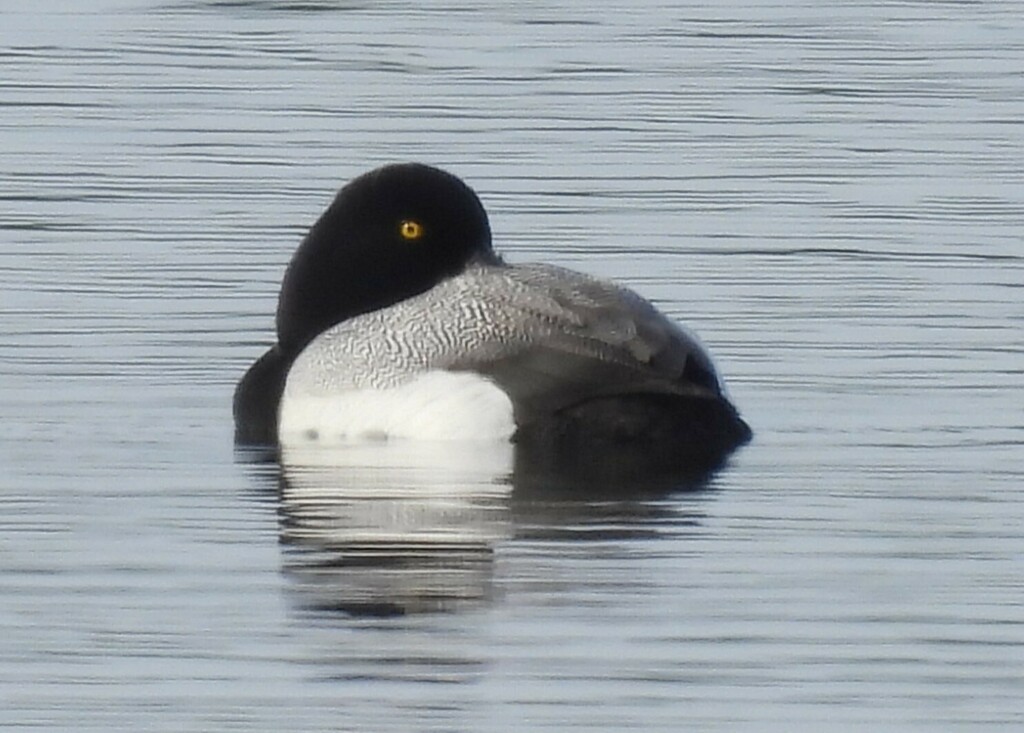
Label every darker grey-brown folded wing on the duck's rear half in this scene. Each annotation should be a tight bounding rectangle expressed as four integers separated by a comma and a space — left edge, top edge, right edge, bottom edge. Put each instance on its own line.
447, 265, 721, 424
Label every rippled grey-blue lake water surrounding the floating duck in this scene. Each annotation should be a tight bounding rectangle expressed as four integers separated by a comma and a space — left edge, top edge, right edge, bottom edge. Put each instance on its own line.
0, 0, 1024, 732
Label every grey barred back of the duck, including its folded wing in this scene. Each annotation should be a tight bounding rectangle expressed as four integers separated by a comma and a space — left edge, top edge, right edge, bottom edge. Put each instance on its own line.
286, 264, 720, 413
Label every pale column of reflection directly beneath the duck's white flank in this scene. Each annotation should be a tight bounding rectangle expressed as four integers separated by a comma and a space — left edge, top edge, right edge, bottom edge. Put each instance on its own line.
281, 442, 512, 615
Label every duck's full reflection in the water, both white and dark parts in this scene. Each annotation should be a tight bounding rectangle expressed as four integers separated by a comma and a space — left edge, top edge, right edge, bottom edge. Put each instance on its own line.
262, 441, 712, 616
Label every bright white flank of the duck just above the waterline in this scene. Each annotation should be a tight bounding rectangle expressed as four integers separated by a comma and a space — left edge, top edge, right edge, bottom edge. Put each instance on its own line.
279, 371, 515, 445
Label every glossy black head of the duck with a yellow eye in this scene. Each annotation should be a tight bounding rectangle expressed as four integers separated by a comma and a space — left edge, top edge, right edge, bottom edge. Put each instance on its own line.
278, 163, 499, 353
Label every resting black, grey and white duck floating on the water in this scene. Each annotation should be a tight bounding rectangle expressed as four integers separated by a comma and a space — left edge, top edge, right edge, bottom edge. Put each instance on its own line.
234, 164, 751, 463
